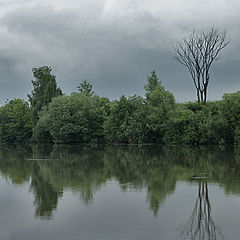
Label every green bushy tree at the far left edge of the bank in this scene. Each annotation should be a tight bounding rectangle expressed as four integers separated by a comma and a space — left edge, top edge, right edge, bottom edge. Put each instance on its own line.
0, 99, 32, 144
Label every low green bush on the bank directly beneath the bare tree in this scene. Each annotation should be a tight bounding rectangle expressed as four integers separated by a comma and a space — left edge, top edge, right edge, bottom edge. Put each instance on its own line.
164, 102, 228, 145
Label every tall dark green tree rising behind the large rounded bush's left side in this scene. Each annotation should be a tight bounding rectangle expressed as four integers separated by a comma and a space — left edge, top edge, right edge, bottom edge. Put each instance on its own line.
28, 66, 62, 126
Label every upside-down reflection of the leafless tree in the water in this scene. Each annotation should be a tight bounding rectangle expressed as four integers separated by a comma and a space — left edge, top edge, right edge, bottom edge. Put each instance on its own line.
180, 181, 224, 240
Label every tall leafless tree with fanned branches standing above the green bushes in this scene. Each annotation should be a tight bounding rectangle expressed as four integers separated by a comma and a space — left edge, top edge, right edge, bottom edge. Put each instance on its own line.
173, 28, 230, 104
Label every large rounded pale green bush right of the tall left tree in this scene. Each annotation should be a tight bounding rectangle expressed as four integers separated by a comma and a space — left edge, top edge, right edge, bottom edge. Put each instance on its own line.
34, 93, 109, 143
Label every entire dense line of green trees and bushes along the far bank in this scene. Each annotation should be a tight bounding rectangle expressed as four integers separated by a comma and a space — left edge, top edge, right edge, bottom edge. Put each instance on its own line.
0, 66, 240, 145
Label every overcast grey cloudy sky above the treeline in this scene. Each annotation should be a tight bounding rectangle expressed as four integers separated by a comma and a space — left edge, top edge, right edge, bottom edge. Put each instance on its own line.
0, 0, 240, 104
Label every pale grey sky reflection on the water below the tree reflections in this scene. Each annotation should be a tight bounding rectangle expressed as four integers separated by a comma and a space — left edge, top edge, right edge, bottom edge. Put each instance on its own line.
0, 175, 240, 240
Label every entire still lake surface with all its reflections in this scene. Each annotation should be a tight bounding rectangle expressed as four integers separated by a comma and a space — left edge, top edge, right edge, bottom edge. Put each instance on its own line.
0, 146, 240, 240
